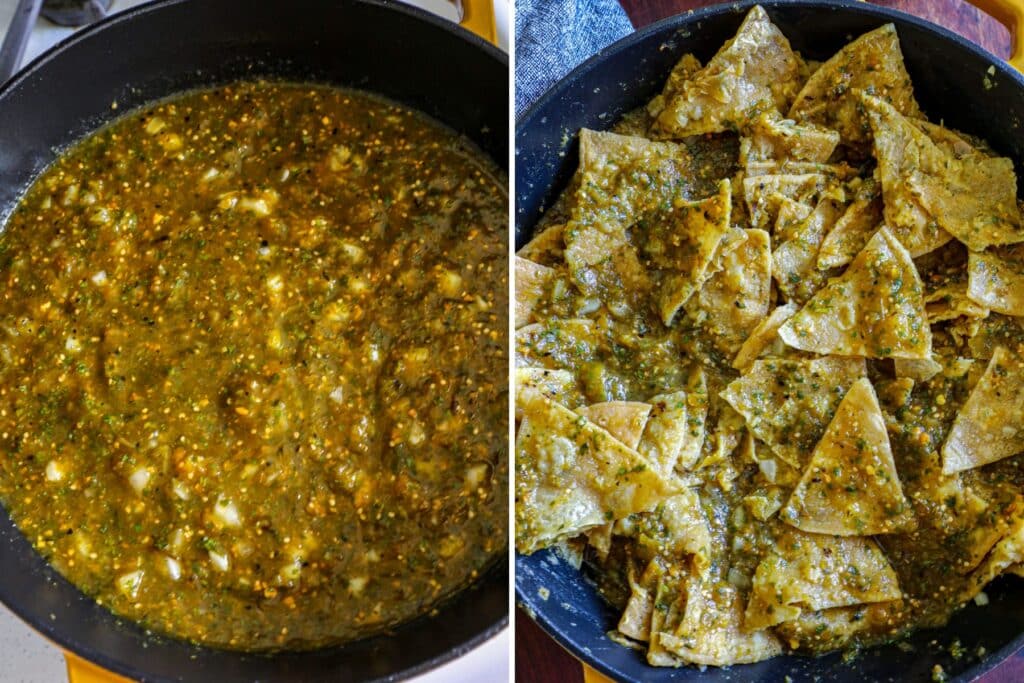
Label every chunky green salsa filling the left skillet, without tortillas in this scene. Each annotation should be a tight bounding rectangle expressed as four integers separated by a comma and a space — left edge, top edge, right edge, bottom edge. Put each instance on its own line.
0, 82, 508, 650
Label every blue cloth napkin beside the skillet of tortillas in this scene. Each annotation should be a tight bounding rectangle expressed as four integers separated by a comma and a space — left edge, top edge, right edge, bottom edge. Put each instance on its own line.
515, 0, 633, 116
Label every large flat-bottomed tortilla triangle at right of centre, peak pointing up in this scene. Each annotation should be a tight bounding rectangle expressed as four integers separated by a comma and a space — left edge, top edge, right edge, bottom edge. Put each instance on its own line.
778, 227, 932, 358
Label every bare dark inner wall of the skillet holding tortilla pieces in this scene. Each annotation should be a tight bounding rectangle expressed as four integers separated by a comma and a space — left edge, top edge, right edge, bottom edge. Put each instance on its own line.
515, 0, 1024, 683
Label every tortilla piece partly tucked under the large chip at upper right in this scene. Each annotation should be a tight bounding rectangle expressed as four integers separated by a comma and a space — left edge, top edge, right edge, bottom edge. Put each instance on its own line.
861, 95, 952, 257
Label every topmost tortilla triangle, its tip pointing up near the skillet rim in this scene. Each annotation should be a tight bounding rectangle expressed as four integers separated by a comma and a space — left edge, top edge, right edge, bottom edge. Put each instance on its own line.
652, 6, 804, 138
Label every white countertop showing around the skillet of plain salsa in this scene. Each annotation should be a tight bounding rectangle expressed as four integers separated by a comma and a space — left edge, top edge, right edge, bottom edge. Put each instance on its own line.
0, 0, 511, 683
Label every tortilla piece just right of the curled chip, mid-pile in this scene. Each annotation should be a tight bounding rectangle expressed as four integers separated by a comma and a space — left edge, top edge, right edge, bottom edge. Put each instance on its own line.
686, 228, 772, 355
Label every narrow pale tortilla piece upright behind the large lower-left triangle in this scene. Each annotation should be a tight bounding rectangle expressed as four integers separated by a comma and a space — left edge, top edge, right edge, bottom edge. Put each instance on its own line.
637, 391, 707, 474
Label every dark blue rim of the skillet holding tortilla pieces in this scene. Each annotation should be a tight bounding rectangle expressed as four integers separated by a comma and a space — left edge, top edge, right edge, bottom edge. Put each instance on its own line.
515, 0, 1024, 683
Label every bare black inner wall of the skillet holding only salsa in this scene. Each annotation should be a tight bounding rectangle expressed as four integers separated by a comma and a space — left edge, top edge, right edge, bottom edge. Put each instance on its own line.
0, 0, 509, 682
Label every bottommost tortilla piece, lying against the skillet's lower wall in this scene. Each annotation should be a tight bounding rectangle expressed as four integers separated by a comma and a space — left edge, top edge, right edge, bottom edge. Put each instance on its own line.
652, 570, 782, 667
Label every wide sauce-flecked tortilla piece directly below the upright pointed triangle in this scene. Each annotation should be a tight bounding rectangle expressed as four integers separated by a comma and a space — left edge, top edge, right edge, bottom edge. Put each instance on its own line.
743, 527, 903, 630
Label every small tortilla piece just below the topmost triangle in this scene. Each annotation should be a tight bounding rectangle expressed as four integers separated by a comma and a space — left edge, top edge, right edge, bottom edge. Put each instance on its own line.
739, 112, 840, 166
